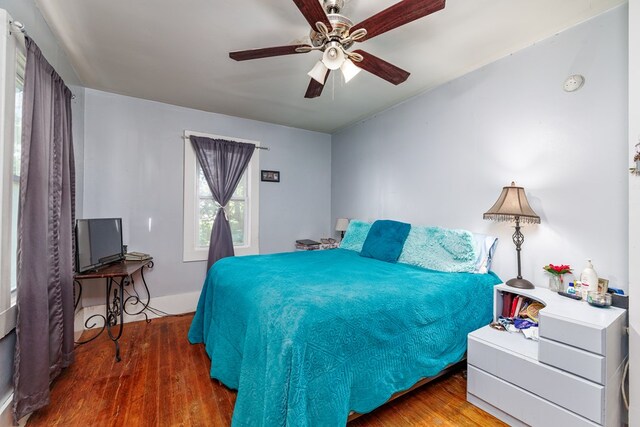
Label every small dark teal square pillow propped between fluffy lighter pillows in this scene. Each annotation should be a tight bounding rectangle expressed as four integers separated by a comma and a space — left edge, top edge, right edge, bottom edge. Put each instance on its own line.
360, 220, 411, 262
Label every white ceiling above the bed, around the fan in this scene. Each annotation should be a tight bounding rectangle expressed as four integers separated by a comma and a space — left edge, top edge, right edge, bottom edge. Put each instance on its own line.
36, 0, 625, 132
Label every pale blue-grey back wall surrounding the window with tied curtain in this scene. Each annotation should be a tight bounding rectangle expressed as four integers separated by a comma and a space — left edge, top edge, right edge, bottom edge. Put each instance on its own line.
84, 89, 331, 308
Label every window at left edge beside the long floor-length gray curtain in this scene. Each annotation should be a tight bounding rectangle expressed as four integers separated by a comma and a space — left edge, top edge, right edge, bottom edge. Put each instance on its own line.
0, 9, 26, 337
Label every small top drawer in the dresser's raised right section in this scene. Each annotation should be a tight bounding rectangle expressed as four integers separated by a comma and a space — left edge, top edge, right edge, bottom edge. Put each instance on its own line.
539, 309, 606, 356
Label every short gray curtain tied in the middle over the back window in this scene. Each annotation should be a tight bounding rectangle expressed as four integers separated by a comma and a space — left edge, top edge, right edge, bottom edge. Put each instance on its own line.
191, 136, 256, 271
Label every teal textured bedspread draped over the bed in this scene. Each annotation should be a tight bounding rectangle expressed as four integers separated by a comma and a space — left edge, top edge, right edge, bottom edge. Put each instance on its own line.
189, 249, 500, 426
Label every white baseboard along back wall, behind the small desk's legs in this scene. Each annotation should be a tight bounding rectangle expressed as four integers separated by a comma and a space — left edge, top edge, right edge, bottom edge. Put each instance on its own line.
80, 291, 200, 328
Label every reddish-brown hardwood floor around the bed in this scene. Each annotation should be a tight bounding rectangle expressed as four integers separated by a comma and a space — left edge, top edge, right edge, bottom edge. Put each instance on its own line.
27, 315, 505, 427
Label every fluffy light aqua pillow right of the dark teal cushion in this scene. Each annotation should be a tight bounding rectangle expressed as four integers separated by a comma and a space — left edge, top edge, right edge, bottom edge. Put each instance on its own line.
398, 226, 478, 273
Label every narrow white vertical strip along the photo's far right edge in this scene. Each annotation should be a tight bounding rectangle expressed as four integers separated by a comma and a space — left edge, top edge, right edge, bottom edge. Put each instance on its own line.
627, 0, 640, 426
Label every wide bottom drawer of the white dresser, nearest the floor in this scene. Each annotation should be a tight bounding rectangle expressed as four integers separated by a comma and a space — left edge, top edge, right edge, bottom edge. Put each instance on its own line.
467, 365, 597, 427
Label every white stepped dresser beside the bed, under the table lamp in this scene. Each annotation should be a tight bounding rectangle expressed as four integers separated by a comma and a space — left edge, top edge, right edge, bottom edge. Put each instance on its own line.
467, 285, 628, 427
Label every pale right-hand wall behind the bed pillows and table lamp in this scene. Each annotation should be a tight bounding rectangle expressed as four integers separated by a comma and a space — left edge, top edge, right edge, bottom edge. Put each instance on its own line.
332, 5, 628, 294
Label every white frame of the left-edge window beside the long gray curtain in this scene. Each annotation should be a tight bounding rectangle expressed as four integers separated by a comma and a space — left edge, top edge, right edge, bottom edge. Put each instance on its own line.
0, 9, 26, 338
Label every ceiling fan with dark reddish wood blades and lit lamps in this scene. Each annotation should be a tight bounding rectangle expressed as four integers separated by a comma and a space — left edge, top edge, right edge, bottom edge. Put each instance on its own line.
229, 0, 445, 98
